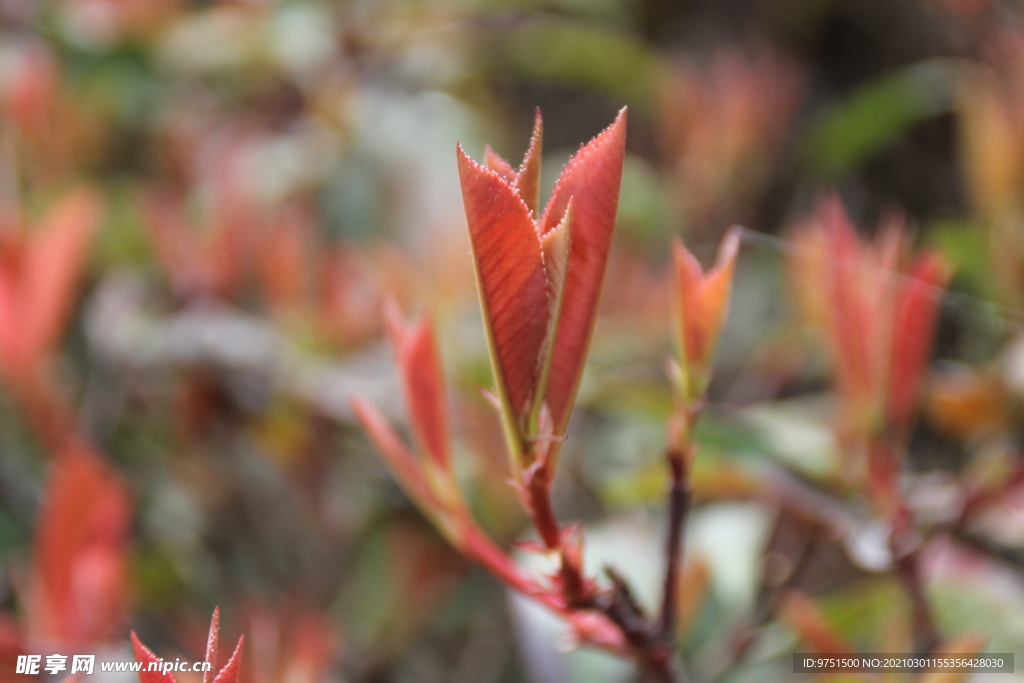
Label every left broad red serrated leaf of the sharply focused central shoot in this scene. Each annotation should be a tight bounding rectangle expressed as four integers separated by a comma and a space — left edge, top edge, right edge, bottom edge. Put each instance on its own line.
459, 146, 560, 420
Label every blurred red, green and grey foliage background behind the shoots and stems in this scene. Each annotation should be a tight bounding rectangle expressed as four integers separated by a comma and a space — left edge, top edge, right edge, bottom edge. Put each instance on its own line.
0, 0, 1024, 683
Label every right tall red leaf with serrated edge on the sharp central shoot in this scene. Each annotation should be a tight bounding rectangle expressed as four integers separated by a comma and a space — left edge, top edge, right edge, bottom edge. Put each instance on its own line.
541, 109, 626, 433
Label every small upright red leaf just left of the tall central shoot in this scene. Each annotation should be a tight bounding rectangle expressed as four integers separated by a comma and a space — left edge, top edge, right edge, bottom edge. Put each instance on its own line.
386, 305, 451, 470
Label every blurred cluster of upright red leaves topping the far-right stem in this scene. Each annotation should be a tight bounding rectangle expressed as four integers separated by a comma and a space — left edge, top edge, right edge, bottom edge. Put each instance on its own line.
794, 197, 949, 433
